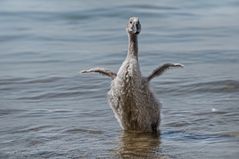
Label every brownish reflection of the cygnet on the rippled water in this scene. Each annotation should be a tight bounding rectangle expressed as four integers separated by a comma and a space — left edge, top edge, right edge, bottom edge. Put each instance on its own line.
117, 132, 164, 159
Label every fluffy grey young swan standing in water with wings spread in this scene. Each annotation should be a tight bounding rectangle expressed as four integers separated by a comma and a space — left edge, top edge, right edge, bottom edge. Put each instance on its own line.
82, 17, 183, 132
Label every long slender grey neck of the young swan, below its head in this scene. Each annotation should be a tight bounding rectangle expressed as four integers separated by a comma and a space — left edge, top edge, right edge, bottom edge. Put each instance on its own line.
128, 34, 138, 60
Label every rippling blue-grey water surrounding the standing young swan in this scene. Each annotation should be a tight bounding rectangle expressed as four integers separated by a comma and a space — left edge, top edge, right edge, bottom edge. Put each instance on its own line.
0, 0, 239, 159
